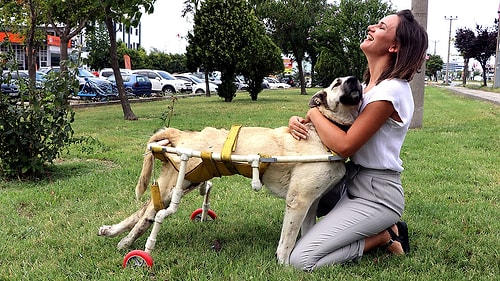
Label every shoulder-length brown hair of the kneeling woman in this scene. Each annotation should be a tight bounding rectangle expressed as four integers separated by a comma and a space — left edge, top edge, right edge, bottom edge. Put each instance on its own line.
363, 10, 428, 84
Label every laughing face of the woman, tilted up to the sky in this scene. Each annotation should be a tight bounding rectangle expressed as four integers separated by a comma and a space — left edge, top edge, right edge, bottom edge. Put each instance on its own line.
360, 15, 399, 56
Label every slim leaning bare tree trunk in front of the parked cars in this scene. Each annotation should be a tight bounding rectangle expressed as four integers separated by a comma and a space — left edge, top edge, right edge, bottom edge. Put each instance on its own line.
105, 6, 137, 120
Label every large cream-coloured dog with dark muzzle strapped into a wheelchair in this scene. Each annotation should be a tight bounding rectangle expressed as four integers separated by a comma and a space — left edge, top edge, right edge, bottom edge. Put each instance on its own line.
98, 77, 363, 264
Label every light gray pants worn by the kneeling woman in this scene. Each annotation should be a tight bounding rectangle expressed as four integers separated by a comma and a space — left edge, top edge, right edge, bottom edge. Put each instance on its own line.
290, 164, 404, 270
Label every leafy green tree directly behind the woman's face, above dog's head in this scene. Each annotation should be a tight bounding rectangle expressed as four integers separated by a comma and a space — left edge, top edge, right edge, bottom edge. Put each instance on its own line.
312, 0, 395, 84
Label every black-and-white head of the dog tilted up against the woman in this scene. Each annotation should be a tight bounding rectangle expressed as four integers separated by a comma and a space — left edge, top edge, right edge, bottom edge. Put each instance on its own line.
309, 76, 363, 126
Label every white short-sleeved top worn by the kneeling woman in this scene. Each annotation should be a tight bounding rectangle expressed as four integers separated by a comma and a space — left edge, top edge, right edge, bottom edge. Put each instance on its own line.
351, 79, 414, 172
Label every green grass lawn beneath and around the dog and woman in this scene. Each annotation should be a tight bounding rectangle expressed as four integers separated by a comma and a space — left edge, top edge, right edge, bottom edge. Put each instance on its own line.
0, 87, 500, 280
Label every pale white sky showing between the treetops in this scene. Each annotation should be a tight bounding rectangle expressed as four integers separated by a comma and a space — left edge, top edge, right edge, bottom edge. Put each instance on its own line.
141, 0, 500, 62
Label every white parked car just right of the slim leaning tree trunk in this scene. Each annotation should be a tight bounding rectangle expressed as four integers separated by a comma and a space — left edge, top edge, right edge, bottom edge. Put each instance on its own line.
132, 69, 193, 93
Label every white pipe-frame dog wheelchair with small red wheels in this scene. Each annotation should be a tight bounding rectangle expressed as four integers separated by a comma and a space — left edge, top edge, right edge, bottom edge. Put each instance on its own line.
122, 138, 343, 267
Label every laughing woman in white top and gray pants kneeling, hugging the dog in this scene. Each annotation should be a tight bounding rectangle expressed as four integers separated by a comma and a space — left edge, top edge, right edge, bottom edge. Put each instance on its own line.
289, 10, 428, 270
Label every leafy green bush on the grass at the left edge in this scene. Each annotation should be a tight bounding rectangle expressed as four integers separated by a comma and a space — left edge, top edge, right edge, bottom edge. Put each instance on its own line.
0, 68, 75, 179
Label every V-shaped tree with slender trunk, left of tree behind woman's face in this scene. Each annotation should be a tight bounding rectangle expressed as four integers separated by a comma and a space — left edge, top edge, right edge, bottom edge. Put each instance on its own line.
253, 0, 327, 94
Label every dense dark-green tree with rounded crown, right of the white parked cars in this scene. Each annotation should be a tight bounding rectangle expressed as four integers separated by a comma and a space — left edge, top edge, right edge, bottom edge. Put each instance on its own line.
186, 0, 264, 102
